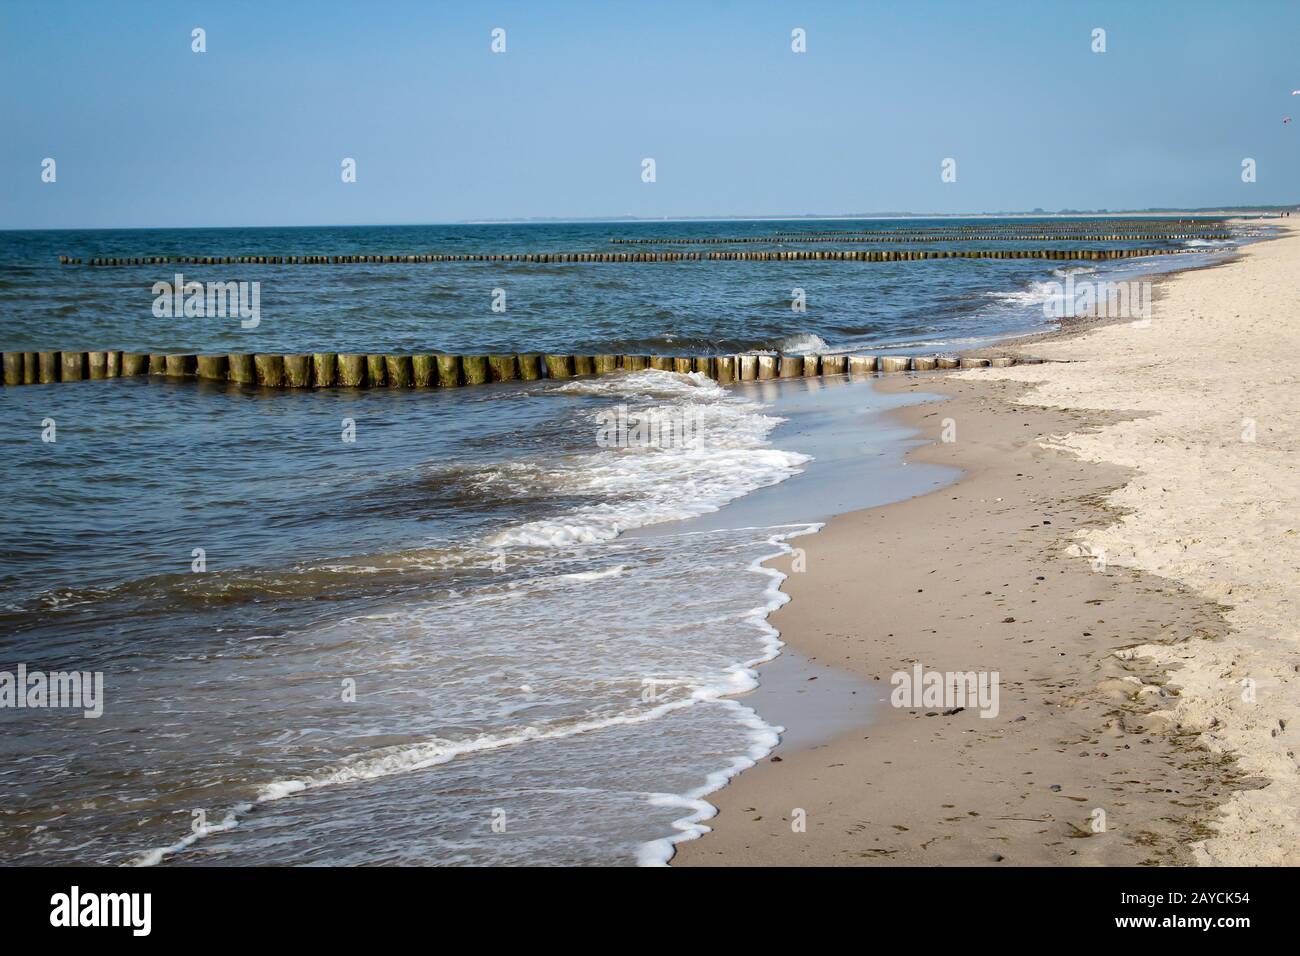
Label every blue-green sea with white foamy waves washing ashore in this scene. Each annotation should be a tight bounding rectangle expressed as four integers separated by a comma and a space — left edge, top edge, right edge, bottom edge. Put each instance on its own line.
0, 219, 1257, 866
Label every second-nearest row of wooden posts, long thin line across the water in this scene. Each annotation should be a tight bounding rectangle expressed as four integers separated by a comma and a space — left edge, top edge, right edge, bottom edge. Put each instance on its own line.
59, 248, 1193, 267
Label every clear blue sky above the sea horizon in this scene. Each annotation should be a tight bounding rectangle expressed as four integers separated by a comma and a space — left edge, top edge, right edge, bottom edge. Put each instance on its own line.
0, 0, 1300, 229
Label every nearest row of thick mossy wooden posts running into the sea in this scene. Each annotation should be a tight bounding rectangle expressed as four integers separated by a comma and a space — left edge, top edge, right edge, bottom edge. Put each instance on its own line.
4, 351, 1040, 389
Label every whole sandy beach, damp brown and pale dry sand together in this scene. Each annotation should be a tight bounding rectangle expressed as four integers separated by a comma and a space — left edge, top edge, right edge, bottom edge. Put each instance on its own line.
673, 221, 1300, 866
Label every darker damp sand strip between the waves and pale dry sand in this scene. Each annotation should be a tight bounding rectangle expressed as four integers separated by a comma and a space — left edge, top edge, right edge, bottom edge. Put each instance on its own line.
672, 228, 1295, 865
